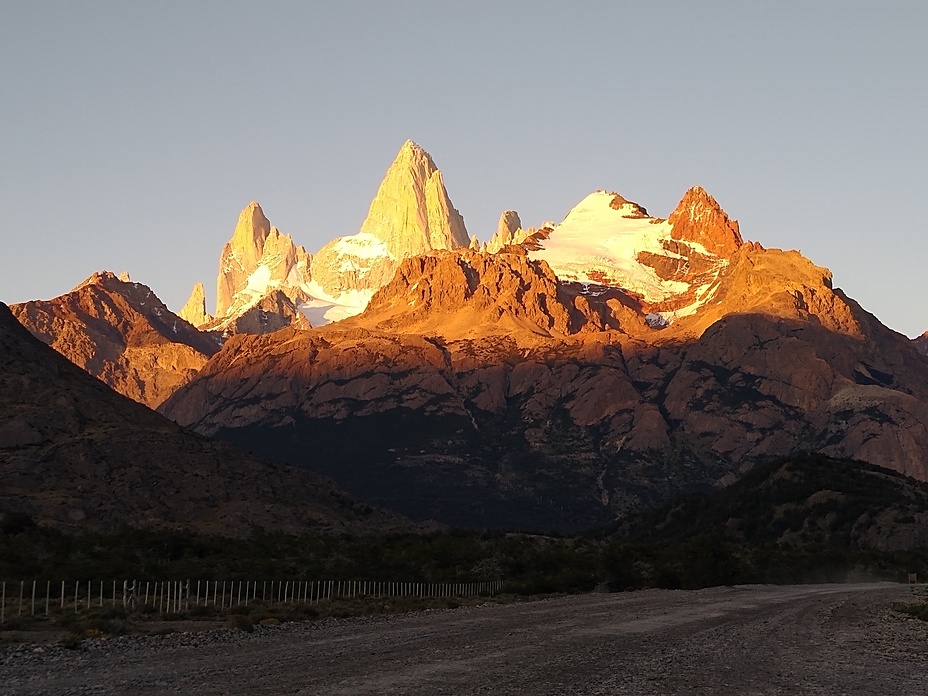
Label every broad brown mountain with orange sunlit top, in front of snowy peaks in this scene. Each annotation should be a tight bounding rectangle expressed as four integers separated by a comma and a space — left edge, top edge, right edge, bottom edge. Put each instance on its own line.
162, 231, 928, 529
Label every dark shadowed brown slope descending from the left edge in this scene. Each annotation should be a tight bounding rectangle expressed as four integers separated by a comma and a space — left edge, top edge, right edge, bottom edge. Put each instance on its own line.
0, 304, 408, 536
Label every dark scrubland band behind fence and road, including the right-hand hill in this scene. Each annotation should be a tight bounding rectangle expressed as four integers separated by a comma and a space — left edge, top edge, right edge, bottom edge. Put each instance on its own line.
7, 455, 928, 594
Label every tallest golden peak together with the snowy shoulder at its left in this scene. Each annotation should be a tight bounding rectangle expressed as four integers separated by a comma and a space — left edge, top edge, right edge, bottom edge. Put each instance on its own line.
312, 140, 470, 318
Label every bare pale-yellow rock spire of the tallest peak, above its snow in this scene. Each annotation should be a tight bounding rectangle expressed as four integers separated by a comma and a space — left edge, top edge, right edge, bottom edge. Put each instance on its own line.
360, 140, 470, 259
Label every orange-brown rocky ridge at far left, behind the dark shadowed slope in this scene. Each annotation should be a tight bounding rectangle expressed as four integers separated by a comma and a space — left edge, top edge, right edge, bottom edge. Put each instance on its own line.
11, 271, 220, 408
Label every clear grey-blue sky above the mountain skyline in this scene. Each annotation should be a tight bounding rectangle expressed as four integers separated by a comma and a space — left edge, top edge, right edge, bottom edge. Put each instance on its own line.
0, 0, 928, 335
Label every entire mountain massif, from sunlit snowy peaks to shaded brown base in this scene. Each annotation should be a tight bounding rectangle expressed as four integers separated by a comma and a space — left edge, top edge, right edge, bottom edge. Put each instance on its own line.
7, 142, 928, 532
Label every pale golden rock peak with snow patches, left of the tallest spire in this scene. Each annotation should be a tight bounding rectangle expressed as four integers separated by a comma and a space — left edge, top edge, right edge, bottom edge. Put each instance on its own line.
212, 202, 312, 333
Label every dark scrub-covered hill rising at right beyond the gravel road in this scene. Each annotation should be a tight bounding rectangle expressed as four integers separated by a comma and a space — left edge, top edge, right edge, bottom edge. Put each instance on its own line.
615, 454, 928, 551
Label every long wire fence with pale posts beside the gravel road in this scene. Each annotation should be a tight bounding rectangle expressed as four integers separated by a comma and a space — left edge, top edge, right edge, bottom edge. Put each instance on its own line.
0, 580, 505, 624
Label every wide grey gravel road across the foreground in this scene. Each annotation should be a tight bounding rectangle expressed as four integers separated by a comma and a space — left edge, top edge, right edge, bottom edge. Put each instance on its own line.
0, 584, 928, 696
